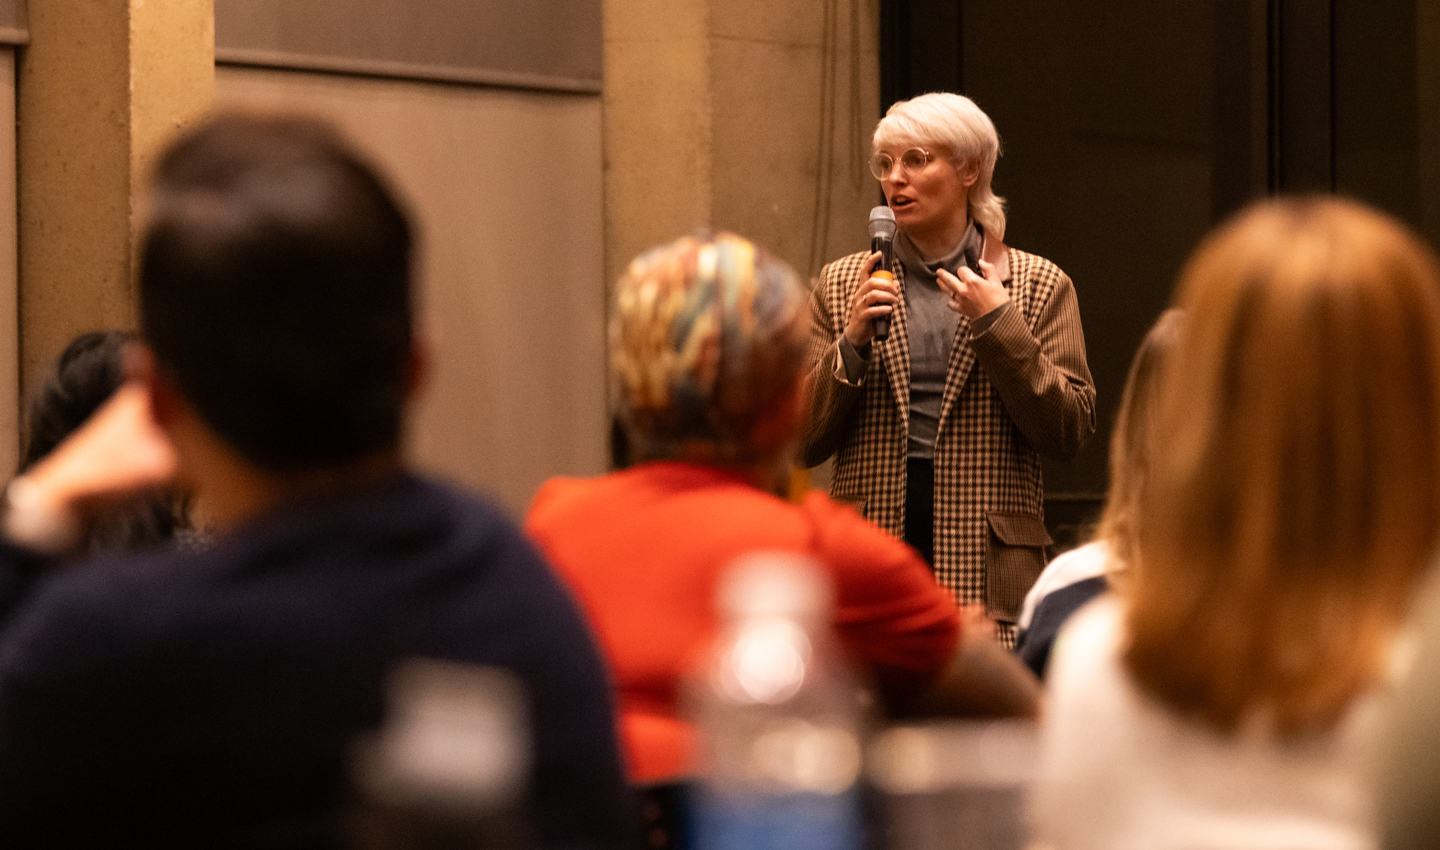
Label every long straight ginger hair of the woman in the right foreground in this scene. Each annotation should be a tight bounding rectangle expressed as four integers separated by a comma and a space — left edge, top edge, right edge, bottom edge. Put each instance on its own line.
1125, 197, 1440, 735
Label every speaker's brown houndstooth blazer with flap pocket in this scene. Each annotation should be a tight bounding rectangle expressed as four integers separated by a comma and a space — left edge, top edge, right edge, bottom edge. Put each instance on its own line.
801, 241, 1094, 631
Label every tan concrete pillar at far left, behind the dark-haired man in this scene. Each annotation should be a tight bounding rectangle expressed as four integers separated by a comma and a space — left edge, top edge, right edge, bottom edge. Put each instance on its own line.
17, 0, 215, 389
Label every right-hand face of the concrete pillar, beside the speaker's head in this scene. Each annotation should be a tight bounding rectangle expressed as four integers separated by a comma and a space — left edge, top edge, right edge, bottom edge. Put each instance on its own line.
710, 0, 880, 275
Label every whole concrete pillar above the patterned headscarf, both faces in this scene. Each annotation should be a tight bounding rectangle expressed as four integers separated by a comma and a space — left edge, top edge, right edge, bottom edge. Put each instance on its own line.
603, 0, 880, 284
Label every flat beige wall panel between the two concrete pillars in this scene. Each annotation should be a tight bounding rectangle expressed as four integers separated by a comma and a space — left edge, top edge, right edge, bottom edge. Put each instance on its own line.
216, 68, 606, 514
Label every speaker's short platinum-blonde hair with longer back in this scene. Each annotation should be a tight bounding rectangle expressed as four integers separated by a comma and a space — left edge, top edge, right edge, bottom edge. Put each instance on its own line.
871, 92, 1005, 241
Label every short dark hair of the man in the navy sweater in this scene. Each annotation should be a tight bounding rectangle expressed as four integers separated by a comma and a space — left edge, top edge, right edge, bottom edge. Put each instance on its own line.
140, 115, 412, 470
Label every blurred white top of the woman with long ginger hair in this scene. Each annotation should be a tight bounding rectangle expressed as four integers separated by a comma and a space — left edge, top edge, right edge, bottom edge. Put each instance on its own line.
1034, 596, 1381, 850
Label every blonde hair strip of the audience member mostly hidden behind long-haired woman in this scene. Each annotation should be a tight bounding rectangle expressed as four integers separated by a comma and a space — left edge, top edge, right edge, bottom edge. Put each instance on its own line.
1096, 307, 1185, 583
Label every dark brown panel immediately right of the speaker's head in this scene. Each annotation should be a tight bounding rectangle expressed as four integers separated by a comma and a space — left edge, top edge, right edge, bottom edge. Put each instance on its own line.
965, 0, 1212, 498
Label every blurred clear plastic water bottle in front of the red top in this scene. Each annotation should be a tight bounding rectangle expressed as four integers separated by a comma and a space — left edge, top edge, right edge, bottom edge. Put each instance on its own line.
685, 553, 864, 850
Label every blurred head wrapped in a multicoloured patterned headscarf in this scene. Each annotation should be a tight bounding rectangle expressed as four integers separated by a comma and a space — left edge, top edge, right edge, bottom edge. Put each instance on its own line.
611, 233, 808, 464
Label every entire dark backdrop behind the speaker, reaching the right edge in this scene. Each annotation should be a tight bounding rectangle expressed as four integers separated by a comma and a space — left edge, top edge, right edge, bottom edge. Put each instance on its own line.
880, 0, 1440, 553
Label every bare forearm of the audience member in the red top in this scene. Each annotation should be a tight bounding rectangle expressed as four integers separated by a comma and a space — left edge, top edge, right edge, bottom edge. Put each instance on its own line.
891, 607, 1040, 717
